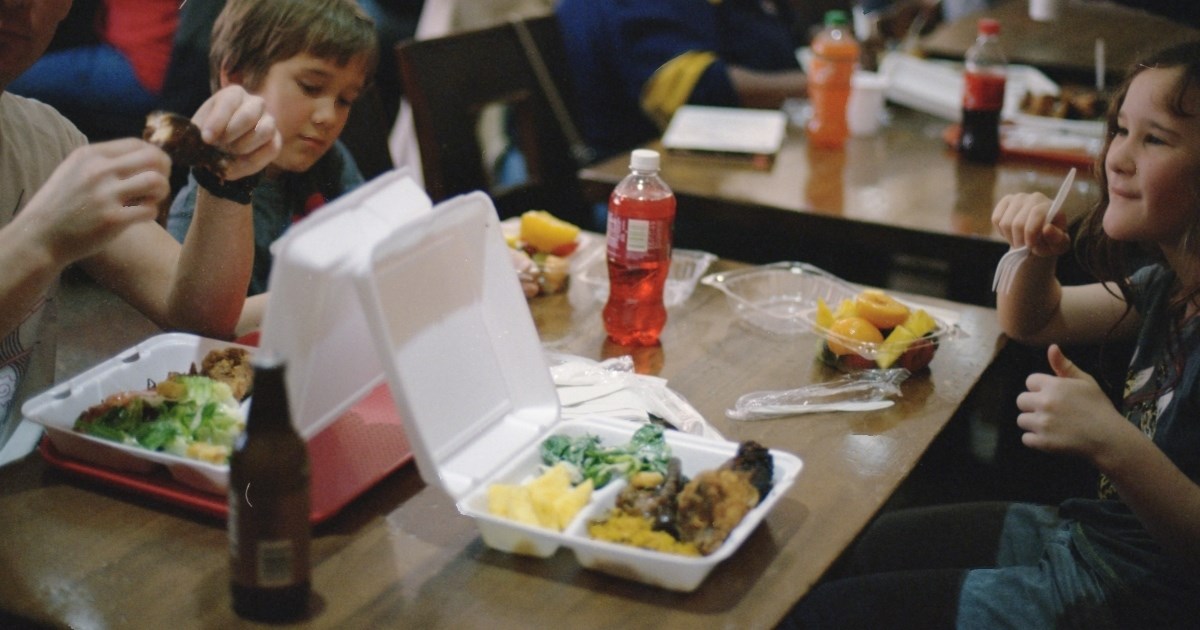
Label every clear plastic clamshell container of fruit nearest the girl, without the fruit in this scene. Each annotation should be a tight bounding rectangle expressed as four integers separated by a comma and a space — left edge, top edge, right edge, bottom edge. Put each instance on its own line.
701, 262, 959, 368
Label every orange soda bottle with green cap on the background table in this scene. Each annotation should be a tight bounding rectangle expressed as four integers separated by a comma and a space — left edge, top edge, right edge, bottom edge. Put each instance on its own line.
808, 11, 860, 149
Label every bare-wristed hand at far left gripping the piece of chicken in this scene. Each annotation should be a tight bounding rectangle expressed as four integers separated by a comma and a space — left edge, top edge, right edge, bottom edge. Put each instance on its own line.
13, 138, 170, 268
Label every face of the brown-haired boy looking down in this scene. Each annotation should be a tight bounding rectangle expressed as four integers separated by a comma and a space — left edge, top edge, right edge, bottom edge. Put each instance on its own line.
246, 53, 367, 173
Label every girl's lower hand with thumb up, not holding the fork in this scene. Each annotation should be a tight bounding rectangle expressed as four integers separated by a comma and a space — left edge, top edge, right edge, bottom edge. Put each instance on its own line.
1016, 344, 1138, 462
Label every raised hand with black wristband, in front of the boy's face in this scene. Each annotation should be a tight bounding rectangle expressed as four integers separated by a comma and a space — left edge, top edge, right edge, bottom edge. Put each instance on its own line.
192, 85, 283, 180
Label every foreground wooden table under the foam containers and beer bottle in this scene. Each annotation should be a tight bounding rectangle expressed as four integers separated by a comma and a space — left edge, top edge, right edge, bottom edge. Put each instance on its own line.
0, 253, 1004, 630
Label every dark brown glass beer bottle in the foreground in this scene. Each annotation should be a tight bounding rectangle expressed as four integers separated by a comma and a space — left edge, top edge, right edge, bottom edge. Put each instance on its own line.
229, 356, 312, 620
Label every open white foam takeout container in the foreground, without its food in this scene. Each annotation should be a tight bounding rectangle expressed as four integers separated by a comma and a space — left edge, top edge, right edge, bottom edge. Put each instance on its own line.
356, 187, 802, 590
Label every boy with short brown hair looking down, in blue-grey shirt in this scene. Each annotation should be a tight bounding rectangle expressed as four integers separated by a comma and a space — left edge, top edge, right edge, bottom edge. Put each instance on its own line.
167, 0, 378, 295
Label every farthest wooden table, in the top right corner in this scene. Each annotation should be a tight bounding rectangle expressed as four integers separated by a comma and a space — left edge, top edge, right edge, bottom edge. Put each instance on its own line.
919, 0, 1200, 88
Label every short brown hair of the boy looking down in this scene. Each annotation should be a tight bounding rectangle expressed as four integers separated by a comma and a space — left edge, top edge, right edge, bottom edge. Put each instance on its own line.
209, 0, 379, 91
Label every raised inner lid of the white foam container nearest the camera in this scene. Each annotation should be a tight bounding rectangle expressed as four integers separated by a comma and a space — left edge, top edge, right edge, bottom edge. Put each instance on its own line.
358, 193, 558, 498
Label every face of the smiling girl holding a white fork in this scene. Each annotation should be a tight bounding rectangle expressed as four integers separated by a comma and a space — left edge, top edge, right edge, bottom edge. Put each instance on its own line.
1104, 68, 1200, 248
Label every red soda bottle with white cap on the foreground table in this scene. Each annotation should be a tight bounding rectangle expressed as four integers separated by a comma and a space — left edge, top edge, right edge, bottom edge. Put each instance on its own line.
604, 149, 676, 346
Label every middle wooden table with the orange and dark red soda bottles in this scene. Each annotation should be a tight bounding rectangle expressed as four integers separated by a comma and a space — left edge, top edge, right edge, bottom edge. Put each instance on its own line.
580, 104, 1099, 305
